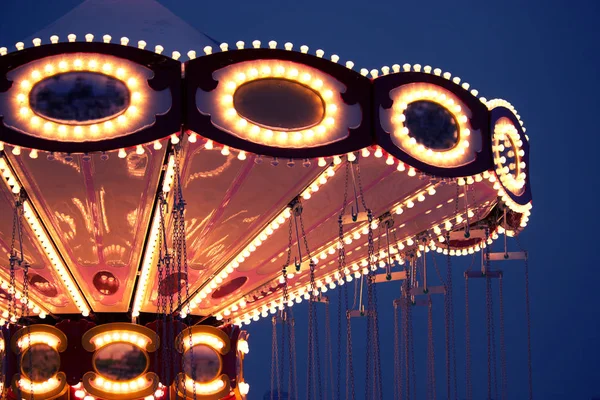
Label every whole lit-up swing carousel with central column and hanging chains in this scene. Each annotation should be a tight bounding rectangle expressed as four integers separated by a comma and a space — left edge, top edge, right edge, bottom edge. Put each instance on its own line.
0, 8, 532, 400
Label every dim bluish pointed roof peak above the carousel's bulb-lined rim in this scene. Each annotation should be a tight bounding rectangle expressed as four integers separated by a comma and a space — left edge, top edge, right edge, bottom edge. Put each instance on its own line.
32, 0, 218, 54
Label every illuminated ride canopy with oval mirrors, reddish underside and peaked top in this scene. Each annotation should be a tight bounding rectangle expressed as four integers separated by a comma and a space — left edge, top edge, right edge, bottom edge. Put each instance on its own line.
0, 4, 531, 323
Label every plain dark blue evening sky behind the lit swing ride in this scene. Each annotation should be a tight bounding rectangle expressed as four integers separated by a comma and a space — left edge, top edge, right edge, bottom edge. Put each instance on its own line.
0, 0, 600, 400
